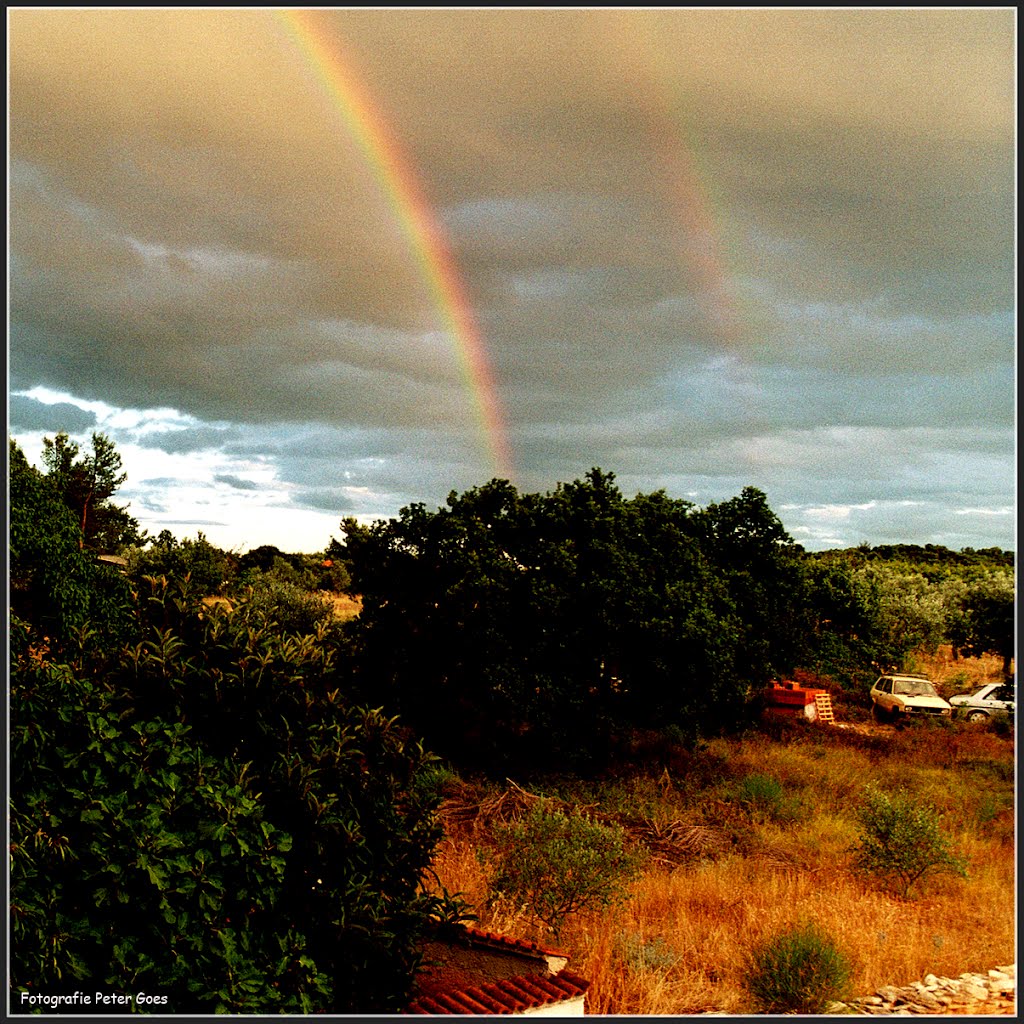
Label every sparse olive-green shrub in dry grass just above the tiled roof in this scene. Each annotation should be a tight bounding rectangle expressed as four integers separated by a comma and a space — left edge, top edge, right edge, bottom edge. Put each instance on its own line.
483, 803, 644, 935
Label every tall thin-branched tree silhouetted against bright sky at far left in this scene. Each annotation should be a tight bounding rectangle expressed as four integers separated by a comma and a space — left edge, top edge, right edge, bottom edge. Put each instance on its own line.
42, 431, 142, 552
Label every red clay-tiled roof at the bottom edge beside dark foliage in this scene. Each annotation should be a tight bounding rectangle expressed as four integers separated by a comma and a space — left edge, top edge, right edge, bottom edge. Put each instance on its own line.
407, 927, 590, 1015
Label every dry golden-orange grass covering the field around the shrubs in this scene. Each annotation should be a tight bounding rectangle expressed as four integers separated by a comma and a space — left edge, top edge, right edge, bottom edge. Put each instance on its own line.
425, 726, 1016, 1015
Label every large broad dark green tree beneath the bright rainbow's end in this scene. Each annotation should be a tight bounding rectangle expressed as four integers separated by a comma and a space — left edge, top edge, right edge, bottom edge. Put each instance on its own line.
335, 469, 805, 770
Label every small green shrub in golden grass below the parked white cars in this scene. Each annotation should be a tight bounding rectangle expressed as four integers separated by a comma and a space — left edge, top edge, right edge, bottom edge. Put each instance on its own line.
854, 790, 967, 897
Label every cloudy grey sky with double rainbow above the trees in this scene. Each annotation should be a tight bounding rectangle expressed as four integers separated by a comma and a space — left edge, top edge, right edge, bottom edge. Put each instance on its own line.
7, 8, 1017, 553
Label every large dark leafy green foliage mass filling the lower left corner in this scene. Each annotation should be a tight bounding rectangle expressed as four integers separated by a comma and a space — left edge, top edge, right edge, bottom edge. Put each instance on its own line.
9, 579, 458, 1014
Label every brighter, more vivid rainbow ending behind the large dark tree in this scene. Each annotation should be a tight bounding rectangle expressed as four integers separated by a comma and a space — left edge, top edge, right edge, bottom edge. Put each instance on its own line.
273, 8, 513, 480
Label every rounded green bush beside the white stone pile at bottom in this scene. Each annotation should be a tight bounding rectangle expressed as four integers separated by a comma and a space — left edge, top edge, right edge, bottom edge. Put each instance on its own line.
746, 924, 851, 1014
